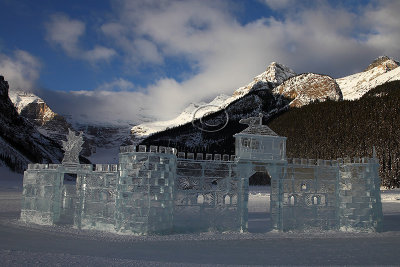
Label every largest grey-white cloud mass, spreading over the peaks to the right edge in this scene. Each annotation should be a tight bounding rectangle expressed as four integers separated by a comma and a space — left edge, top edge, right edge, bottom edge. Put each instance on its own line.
42, 0, 400, 124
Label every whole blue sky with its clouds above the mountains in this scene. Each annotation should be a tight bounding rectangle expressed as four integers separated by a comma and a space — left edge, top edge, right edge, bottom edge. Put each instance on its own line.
0, 0, 400, 122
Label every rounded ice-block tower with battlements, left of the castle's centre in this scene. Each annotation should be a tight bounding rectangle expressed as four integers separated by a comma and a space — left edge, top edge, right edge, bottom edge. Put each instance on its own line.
116, 146, 176, 234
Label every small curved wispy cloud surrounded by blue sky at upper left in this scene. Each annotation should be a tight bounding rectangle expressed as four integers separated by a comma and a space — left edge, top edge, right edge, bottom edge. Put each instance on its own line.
46, 14, 116, 63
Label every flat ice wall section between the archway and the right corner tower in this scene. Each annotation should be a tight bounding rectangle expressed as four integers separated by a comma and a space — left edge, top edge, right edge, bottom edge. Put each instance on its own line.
279, 159, 339, 231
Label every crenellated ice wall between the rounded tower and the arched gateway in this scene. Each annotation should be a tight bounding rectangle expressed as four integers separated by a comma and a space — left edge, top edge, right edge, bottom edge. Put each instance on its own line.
174, 153, 242, 232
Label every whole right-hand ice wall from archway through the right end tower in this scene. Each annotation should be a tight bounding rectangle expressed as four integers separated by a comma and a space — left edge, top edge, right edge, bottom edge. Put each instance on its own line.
271, 158, 383, 231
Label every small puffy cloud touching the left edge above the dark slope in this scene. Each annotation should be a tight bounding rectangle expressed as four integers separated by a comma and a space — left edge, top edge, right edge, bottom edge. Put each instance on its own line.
0, 50, 41, 91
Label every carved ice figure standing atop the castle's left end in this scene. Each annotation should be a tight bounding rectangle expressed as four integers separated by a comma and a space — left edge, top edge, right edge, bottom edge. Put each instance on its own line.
62, 129, 84, 164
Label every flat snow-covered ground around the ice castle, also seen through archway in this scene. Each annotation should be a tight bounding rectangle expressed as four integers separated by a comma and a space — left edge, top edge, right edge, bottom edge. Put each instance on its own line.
0, 174, 400, 266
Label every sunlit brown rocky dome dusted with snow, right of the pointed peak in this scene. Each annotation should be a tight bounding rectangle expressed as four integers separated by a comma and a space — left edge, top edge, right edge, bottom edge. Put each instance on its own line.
272, 73, 343, 107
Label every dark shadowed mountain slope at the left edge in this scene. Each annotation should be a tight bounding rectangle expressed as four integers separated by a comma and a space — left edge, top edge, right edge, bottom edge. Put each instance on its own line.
0, 76, 63, 172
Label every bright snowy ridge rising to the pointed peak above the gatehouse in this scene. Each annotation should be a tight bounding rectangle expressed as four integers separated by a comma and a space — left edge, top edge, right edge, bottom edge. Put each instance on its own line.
131, 62, 296, 140
